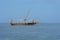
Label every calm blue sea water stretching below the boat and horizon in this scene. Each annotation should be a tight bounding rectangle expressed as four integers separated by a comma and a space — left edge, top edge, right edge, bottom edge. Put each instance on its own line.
0, 23, 60, 40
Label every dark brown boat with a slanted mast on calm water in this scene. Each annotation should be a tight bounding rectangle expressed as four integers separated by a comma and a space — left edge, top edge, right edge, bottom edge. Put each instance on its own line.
10, 9, 38, 25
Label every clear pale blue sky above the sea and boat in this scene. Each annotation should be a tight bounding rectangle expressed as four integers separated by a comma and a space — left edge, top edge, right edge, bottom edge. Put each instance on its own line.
0, 0, 60, 23
